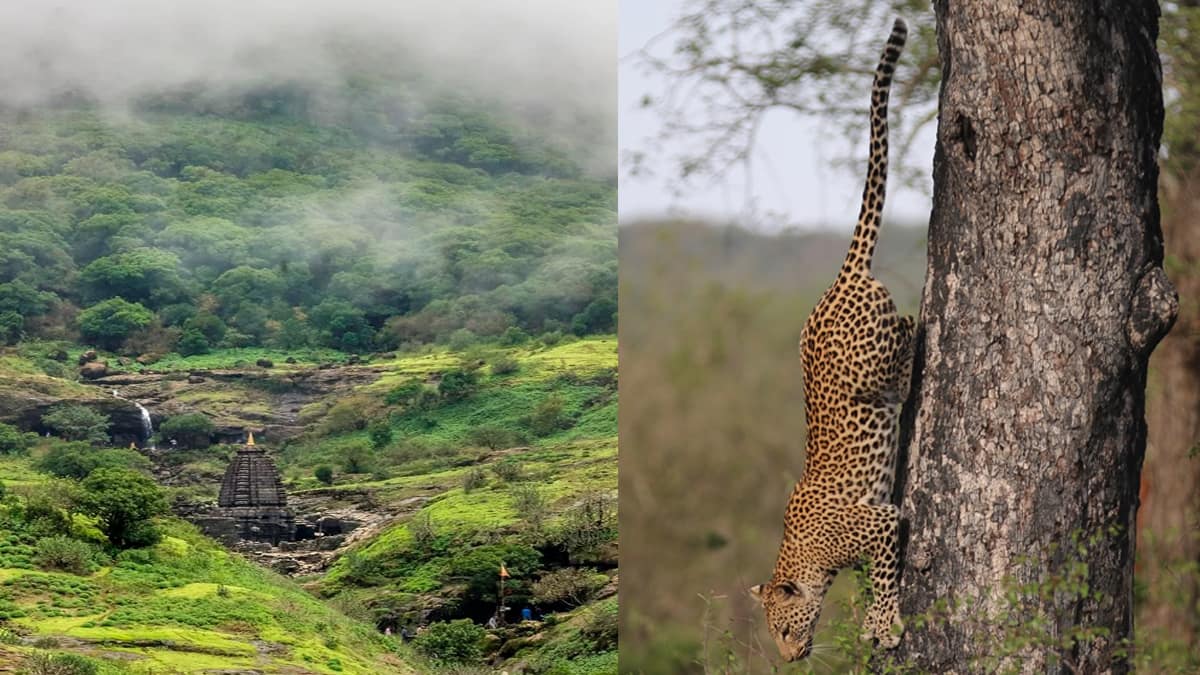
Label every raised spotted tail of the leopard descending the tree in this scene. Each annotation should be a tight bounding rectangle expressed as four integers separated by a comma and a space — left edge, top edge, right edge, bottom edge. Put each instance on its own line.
842, 18, 908, 273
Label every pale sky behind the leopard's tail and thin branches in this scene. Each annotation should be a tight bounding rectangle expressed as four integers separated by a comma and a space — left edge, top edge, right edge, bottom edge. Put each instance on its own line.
618, 0, 934, 232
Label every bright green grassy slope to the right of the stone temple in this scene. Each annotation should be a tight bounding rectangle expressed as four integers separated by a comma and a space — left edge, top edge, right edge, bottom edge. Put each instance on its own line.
296, 338, 617, 673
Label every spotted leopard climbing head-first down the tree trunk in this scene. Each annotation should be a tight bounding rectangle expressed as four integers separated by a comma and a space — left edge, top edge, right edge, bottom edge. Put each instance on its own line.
750, 18, 916, 661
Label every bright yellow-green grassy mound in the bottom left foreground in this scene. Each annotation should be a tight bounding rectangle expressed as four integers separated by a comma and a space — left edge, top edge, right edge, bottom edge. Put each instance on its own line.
0, 458, 410, 674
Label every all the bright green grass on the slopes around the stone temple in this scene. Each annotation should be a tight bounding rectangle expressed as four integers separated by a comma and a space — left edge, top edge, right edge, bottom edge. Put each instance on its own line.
0, 338, 617, 675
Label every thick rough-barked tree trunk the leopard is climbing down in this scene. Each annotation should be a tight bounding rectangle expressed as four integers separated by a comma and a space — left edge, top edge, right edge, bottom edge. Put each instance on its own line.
892, 0, 1177, 674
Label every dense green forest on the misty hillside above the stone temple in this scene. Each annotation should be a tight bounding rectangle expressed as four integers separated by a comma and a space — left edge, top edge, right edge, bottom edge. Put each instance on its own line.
0, 78, 617, 360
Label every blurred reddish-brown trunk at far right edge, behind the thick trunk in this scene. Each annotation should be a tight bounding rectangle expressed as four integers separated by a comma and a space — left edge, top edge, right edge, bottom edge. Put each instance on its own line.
1138, 166, 1200, 645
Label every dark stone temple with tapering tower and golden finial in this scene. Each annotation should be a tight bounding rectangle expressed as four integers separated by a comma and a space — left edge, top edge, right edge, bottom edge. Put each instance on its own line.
204, 432, 295, 546
